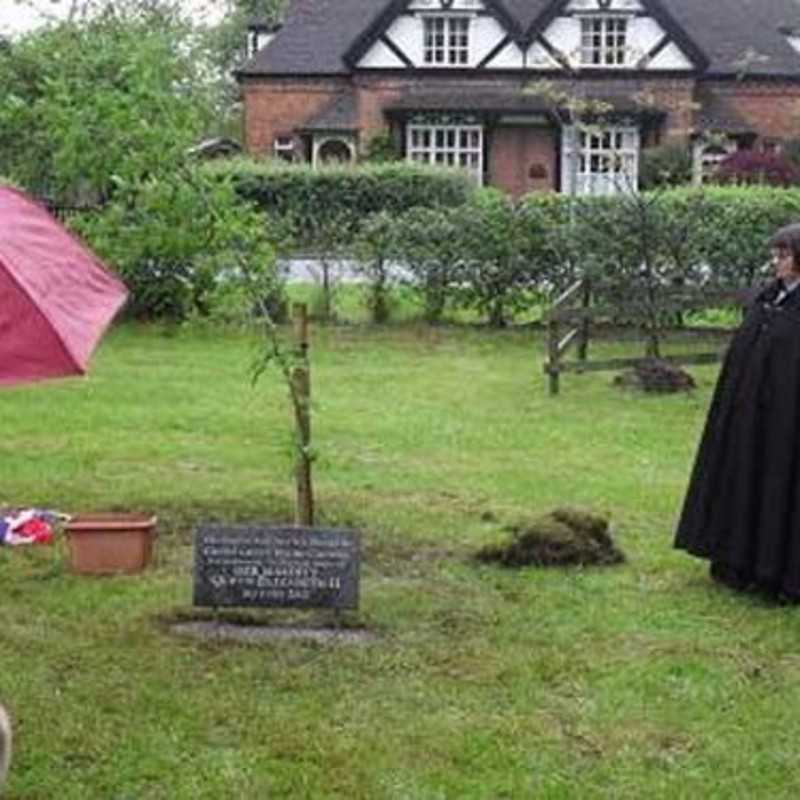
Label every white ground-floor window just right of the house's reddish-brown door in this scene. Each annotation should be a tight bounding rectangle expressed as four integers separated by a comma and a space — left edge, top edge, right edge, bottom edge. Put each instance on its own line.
562, 125, 641, 195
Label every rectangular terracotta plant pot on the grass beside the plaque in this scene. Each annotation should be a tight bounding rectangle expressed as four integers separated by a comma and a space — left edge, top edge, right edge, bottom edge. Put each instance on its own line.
64, 513, 156, 575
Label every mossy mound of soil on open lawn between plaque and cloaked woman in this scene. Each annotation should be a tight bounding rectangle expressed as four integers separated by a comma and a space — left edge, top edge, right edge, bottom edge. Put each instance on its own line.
476, 508, 625, 567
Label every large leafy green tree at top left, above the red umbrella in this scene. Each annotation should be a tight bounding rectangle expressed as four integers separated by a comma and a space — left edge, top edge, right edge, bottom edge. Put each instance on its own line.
0, 0, 215, 203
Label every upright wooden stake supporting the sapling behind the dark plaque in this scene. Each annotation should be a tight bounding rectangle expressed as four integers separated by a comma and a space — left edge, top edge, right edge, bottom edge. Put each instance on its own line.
292, 303, 314, 526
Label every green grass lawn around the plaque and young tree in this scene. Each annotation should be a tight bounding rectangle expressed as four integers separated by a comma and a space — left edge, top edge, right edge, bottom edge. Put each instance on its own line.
0, 325, 800, 800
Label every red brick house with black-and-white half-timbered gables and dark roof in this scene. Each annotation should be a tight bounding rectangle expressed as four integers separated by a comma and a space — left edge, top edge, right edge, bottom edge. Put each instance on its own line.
237, 0, 800, 196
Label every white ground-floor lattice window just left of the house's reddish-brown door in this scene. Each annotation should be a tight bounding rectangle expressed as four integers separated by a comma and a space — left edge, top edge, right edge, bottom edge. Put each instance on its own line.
406, 124, 483, 185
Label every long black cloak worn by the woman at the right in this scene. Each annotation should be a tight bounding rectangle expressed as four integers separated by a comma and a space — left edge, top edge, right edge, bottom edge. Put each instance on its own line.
675, 282, 800, 599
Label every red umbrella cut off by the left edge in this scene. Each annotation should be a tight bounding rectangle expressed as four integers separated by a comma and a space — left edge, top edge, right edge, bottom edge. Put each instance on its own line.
0, 187, 128, 384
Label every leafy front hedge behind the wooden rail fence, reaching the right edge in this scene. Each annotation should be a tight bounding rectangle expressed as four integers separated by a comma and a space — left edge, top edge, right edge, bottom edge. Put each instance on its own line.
352, 187, 800, 325
